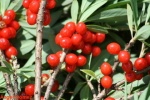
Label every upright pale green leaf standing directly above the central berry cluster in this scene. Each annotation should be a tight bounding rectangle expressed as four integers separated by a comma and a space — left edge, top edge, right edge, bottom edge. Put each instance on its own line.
71, 0, 79, 23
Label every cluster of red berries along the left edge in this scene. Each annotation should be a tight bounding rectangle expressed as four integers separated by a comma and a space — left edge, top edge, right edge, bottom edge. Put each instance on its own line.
0, 10, 20, 59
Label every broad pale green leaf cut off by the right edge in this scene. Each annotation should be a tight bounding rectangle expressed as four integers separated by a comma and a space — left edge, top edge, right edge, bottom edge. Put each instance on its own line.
134, 25, 150, 41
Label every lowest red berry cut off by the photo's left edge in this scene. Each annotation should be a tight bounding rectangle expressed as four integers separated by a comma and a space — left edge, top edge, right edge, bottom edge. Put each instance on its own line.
0, 38, 10, 50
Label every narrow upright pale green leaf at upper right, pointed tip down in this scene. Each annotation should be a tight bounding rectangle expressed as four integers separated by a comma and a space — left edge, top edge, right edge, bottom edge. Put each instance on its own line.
127, 4, 133, 37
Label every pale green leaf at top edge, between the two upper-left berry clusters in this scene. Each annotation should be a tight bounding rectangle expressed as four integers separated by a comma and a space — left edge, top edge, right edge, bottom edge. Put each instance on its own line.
7, 0, 23, 11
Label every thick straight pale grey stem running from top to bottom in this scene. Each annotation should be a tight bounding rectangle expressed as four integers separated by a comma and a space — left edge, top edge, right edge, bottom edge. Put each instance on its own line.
34, 0, 46, 100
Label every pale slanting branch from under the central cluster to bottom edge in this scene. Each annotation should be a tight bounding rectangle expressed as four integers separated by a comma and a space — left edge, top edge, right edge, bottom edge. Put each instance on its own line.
44, 51, 67, 100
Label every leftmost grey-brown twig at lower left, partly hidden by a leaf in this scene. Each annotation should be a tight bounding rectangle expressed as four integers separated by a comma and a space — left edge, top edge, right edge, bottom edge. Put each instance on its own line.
0, 50, 14, 96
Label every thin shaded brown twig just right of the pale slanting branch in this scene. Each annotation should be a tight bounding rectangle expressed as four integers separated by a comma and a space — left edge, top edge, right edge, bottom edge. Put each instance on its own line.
55, 73, 73, 100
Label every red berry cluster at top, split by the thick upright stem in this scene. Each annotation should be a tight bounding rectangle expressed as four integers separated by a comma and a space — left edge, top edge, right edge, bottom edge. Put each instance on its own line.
22, 0, 56, 26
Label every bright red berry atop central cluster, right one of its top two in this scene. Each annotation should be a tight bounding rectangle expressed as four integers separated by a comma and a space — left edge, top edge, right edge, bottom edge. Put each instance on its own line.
76, 22, 87, 35
